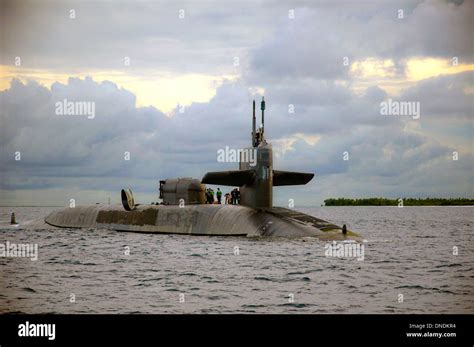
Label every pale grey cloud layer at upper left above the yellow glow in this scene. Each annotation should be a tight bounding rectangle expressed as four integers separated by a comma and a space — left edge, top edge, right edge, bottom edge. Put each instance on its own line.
1, 1, 274, 74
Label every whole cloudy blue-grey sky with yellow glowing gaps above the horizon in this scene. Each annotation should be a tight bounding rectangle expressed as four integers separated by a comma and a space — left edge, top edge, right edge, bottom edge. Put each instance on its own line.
0, 0, 474, 207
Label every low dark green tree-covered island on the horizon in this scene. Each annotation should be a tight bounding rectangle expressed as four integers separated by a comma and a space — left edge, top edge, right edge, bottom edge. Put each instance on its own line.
324, 198, 474, 206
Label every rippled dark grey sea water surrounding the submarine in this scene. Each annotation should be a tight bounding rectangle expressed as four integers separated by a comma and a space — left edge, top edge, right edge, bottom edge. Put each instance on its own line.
0, 207, 474, 313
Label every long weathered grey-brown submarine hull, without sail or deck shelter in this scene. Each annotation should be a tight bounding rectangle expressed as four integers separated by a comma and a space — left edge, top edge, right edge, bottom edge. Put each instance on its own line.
45, 205, 361, 241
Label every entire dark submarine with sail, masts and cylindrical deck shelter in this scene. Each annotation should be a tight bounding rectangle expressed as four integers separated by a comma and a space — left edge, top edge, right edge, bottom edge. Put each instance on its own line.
44, 97, 362, 241
